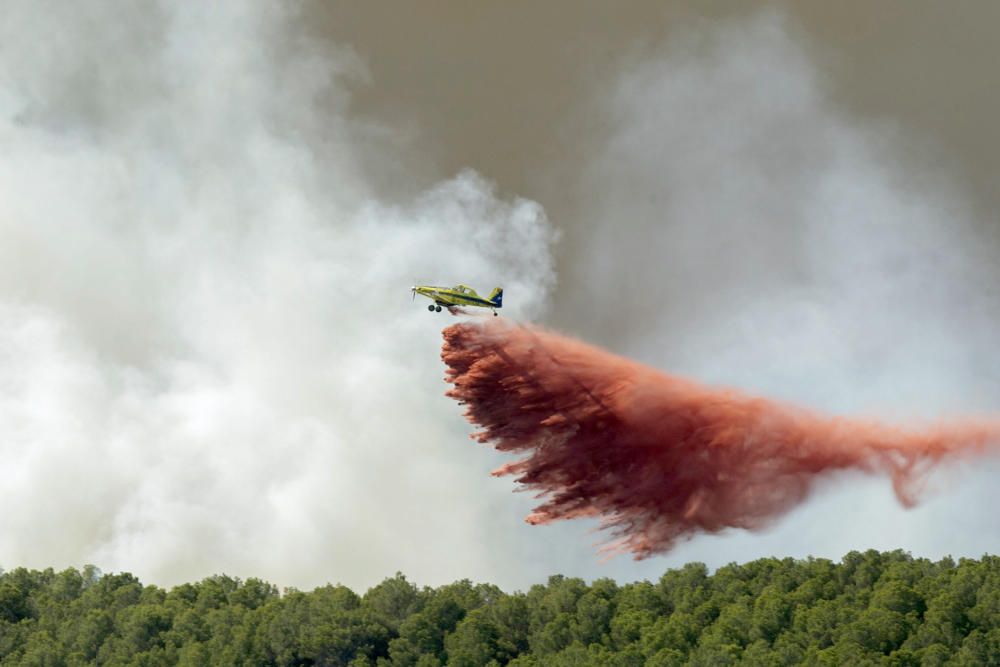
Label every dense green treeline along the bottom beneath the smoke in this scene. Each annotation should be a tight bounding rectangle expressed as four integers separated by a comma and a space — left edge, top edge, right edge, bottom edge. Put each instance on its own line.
0, 551, 1000, 667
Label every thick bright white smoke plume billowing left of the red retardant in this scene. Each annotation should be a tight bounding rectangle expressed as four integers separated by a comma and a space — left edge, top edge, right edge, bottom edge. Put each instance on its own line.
0, 1, 554, 587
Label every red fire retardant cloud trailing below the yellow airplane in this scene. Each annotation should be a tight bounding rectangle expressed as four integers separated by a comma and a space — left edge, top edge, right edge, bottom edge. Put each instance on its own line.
441, 321, 1000, 558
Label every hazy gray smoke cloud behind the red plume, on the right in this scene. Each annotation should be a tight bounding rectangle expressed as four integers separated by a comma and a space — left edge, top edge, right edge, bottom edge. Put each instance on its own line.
556, 12, 1000, 567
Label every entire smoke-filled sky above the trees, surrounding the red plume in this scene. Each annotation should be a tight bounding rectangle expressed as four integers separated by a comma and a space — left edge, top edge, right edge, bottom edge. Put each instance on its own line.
0, 0, 1000, 590
